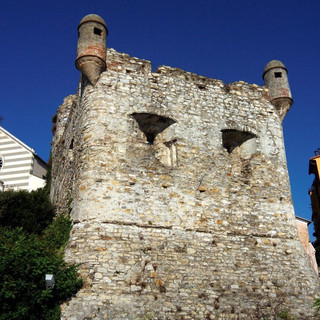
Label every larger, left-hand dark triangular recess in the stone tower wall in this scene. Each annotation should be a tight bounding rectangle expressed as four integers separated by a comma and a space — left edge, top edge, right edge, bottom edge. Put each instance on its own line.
132, 113, 175, 144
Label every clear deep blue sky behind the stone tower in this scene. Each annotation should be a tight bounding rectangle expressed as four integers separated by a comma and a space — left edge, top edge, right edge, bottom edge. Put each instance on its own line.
0, 0, 320, 235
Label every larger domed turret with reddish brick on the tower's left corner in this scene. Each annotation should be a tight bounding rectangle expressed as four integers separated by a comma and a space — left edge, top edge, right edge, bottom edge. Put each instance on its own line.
75, 14, 108, 86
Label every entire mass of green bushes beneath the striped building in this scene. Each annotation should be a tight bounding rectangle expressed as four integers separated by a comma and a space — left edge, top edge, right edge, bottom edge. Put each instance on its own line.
0, 189, 82, 320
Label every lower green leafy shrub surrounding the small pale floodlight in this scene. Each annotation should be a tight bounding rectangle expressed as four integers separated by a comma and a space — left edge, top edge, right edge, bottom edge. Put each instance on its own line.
0, 228, 82, 320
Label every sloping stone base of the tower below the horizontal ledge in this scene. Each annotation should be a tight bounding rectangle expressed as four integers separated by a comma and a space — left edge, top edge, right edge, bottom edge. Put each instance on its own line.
61, 222, 320, 320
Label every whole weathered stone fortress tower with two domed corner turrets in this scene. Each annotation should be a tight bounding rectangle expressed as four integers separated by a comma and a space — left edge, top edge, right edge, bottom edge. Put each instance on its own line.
51, 15, 320, 320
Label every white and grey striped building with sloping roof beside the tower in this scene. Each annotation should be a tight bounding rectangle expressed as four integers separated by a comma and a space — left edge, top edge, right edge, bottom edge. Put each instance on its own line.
0, 126, 47, 191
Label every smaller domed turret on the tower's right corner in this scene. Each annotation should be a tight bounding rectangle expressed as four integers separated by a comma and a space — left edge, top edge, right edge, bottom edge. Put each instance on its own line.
262, 60, 293, 121
